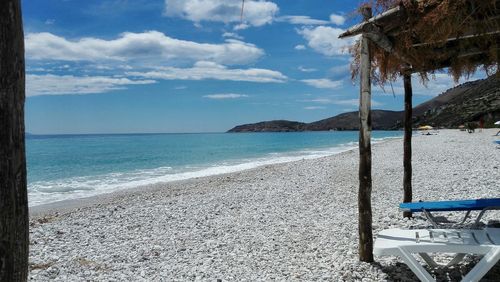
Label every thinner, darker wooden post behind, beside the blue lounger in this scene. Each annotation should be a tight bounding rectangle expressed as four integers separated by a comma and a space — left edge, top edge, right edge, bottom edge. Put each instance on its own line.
403, 73, 413, 218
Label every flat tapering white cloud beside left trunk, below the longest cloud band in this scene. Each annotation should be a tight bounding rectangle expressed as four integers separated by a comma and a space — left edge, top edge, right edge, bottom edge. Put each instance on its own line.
26, 74, 156, 96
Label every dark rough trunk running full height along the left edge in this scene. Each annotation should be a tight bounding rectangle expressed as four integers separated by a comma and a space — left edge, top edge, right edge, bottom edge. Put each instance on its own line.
0, 0, 29, 282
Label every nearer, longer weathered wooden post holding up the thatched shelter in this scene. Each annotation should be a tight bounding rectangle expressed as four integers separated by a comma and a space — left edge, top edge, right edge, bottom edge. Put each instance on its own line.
358, 6, 373, 262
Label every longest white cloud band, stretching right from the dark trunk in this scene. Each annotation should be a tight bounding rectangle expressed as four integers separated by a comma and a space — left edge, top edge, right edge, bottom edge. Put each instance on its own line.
25, 31, 264, 65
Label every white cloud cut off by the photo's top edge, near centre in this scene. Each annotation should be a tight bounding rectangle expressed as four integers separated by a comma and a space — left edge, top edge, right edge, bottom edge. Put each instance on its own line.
164, 0, 279, 26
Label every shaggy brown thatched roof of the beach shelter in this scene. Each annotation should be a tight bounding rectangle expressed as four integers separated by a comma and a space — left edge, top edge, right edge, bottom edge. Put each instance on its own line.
339, 0, 500, 81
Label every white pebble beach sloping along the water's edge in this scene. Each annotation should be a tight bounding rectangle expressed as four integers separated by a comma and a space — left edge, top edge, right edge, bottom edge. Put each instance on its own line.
29, 129, 500, 281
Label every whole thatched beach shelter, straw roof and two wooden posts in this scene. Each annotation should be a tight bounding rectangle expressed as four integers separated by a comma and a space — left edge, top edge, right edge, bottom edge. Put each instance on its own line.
339, 0, 500, 262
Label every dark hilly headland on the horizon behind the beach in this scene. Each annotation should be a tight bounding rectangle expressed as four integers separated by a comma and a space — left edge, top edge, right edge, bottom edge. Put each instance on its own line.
228, 76, 500, 132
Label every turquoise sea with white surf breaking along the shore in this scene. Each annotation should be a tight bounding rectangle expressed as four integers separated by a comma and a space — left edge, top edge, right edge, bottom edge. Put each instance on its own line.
26, 131, 402, 206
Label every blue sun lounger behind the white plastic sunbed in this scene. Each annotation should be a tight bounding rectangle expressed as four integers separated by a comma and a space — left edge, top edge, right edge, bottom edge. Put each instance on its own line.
399, 198, 500, 228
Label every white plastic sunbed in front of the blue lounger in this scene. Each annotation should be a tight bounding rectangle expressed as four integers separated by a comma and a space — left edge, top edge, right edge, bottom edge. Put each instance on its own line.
373, 228, 500, 281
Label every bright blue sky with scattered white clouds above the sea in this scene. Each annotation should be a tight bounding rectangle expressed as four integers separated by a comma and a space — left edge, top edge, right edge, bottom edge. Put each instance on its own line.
22, 0, 484, 134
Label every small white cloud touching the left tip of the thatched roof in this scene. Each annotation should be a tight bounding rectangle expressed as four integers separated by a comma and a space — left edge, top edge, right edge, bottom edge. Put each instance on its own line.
297, 26, 353, 57
